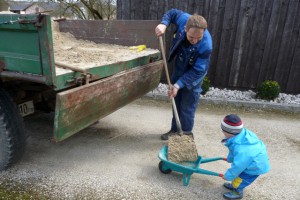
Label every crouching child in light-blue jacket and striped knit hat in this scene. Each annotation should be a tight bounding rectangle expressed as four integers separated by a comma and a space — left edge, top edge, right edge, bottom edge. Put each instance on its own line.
221, 114, 270, 199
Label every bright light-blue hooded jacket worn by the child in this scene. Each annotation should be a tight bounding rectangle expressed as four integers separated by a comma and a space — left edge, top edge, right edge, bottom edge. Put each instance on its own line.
224, 128, 270, 181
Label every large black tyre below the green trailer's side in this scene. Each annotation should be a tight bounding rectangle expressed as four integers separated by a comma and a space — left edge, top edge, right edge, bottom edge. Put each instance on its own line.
0, 88, 26, 171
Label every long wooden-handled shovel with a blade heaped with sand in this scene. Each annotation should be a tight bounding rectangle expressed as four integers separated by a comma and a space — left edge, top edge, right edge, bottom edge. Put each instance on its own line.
159, 36, 198, 163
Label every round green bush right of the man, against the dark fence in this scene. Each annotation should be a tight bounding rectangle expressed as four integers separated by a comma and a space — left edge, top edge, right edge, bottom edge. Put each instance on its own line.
256, 80, 280, 100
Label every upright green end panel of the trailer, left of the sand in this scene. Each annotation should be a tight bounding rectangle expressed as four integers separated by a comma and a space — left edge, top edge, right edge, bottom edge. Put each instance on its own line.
0, 14, 55, 85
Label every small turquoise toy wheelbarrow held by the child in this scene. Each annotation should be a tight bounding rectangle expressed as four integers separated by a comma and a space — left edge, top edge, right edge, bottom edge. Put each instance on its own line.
158, 146, 227, 186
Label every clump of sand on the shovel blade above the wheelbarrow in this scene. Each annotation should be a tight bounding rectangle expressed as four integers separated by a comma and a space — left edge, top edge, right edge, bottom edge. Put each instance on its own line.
168, 135, 198, 163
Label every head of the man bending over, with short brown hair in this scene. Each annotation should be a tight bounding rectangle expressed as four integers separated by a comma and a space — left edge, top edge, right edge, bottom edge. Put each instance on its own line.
185, 14, 207, 45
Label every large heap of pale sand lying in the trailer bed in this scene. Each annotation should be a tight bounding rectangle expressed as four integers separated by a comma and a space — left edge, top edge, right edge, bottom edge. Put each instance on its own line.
52, 21, 159, 74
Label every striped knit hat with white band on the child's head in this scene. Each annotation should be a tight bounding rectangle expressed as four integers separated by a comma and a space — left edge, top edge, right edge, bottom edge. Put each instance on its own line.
221, 114, 243, 135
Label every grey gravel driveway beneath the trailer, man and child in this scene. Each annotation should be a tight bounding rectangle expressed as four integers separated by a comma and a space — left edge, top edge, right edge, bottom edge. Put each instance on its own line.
0, 99, 300, 200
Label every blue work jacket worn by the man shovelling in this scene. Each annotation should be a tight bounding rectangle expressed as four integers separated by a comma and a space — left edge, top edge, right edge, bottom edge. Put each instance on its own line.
161, 9, 212, 92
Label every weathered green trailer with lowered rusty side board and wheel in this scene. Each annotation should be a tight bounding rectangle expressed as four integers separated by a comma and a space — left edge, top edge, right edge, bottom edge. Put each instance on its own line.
0, 14, 163, 170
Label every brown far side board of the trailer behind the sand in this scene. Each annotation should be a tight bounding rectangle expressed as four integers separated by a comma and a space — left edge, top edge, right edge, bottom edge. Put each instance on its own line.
60, 20, 160, 49
